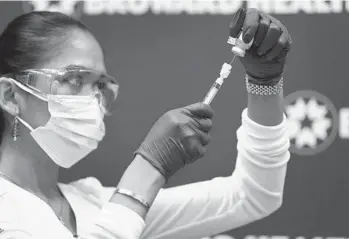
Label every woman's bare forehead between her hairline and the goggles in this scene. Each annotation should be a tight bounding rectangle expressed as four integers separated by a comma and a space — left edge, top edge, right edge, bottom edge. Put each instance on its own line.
41, 31, 106, 72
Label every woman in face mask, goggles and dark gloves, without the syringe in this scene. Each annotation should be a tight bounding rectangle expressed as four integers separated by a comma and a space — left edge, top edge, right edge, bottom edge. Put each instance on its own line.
0, 9, 291, 239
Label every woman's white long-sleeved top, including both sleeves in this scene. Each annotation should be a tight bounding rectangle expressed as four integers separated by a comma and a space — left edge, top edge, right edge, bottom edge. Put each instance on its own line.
0, 110, 290, 239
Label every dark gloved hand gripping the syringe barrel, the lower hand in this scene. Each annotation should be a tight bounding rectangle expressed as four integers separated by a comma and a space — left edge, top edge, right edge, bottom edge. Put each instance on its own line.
135, 103, 213, 181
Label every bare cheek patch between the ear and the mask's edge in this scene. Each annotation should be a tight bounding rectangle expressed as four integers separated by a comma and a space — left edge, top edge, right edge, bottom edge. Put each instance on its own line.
22, 96, 50, 129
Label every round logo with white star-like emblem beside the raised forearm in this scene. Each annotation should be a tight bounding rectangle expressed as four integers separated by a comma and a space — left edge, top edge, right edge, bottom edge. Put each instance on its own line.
285, 90, 338, 155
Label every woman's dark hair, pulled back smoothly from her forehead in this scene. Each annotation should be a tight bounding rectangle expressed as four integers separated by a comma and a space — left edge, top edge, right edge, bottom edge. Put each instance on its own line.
0, 11, 89, 142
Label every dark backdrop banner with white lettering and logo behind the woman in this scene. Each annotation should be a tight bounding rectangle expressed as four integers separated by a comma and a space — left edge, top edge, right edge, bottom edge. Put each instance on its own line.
0, 0, 349, 239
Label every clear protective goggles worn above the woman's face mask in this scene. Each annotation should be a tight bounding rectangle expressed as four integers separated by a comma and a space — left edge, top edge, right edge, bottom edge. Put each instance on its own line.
5, 67, 119, 113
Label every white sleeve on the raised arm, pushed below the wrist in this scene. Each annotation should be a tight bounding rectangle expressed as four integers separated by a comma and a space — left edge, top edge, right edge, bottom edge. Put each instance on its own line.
137, 109, 290, 239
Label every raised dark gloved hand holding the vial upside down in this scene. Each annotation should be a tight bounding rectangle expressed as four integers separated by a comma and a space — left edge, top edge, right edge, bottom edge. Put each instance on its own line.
229, 8, 292, 85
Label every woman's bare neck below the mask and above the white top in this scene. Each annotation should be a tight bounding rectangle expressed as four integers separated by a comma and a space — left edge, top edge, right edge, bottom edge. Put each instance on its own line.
0, 132, 59, 199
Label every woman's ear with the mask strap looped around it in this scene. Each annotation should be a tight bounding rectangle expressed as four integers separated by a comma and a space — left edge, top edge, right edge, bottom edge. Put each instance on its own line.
0, 77, 19, 116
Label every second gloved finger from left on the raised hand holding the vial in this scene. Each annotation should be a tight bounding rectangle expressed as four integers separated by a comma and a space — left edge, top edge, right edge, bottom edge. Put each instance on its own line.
242, 8, 260, 43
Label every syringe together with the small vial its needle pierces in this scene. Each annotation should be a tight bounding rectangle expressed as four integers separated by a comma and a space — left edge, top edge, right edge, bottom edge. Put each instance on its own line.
202, 34, 253, 105
